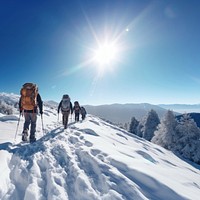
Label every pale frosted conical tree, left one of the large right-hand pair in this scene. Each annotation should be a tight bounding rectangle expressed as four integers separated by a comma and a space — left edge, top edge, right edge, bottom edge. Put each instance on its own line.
151, 110, 177, 149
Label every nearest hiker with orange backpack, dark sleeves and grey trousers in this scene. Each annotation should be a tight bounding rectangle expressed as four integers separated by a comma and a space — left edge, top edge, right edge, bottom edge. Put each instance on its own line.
19, 83, 43, 143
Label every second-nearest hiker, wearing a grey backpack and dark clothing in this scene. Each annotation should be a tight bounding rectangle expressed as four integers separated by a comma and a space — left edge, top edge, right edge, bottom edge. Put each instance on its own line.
58, 94, 73, 129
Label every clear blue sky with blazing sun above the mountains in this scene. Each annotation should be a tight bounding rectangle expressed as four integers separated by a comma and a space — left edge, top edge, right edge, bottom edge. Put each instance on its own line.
0, 0, 200, 105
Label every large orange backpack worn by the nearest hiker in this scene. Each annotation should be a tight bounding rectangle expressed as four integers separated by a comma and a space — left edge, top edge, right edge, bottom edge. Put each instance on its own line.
20, 83, 38, 110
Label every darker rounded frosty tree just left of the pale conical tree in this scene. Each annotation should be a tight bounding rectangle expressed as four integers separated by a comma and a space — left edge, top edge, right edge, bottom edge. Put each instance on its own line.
138, 109, 160, 141
